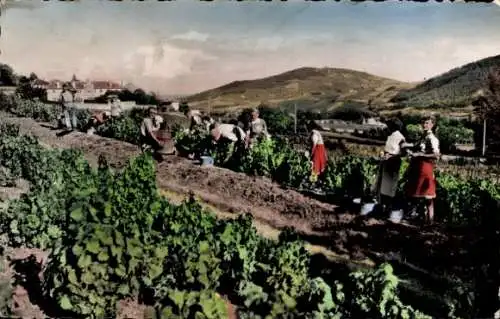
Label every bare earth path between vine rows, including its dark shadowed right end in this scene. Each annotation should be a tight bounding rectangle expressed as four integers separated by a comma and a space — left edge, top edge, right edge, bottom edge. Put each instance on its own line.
0, 113, 479, 318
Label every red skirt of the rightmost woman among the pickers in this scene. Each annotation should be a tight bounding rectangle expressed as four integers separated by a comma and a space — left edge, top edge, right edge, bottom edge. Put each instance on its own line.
406, 159, 436, 199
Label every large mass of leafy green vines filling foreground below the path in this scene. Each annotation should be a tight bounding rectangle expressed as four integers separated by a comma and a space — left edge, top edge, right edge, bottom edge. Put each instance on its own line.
0, 126, 430, 318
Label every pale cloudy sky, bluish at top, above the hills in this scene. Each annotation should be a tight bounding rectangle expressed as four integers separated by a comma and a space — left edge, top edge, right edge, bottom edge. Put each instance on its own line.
0, 0, 500, 94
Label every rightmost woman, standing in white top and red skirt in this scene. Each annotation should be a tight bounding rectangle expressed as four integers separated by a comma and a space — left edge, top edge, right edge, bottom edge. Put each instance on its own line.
406, 117, 440, 224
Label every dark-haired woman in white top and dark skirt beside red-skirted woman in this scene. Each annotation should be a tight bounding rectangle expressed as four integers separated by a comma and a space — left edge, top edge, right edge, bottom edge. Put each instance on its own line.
374, 119, 412, 216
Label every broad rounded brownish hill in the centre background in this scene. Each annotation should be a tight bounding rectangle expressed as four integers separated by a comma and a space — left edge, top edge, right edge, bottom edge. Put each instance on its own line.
187, 67, 413, 111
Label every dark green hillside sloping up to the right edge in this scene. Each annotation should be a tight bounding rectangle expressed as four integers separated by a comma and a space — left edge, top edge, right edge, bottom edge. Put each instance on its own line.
391, 55, 500, 109
